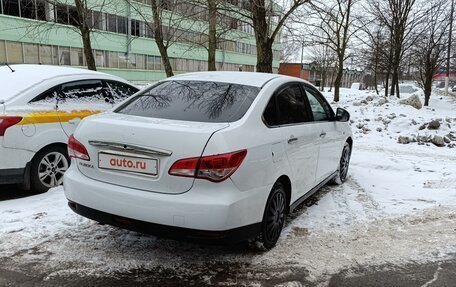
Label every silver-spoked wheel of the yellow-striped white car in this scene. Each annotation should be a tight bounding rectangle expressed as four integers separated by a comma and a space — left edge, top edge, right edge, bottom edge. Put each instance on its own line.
30, 145, 70, 193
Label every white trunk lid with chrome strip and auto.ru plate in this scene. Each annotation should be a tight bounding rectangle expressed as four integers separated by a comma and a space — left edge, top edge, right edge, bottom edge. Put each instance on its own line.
75, 113, 229, 194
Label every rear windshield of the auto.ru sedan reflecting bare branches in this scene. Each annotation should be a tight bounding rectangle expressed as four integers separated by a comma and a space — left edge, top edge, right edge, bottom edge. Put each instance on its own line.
116, 81, 260, 123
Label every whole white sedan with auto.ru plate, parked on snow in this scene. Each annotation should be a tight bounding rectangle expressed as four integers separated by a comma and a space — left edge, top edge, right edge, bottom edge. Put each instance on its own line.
64, 72, 353, 249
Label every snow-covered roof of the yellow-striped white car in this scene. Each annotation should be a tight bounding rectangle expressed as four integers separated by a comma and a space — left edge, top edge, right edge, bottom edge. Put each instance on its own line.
0, 64, 125, 100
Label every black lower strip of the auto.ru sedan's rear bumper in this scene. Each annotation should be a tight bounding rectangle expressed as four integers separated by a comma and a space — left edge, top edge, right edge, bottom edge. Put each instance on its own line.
68, 201, 261, 244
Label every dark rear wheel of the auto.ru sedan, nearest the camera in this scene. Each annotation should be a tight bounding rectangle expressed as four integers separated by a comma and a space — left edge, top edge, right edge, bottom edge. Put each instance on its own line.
251, 182, 287, 251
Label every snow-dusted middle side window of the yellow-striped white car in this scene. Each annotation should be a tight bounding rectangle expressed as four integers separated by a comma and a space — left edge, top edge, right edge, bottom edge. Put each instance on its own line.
61, 80, 112, 103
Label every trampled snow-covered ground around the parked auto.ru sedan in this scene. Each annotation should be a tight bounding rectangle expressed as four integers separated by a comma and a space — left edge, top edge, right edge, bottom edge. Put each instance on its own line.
0, 89, 456, 286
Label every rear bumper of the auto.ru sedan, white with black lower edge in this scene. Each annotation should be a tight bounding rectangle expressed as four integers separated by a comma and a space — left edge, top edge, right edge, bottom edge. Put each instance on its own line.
63, 165, 269, 238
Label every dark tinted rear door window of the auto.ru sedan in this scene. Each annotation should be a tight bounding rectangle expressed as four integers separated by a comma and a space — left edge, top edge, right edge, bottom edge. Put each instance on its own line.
263, 85, 310, 126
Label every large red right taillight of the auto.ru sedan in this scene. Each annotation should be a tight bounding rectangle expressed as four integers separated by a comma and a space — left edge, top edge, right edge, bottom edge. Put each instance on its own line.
168, 150, 247, 182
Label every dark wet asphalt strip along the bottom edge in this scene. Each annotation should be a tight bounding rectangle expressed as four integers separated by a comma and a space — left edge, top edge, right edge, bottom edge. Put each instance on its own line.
0, 253, 456, 287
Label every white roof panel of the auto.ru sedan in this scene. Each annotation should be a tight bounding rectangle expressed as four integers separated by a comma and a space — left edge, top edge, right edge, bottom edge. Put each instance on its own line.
167, 72, 285, 87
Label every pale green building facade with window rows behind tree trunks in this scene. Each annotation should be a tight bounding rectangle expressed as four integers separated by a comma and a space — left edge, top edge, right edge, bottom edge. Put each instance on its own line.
0, 0, 280, 82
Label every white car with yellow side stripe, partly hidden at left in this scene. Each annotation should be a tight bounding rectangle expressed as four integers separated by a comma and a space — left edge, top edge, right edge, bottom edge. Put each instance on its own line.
0, 65, 138, 193
